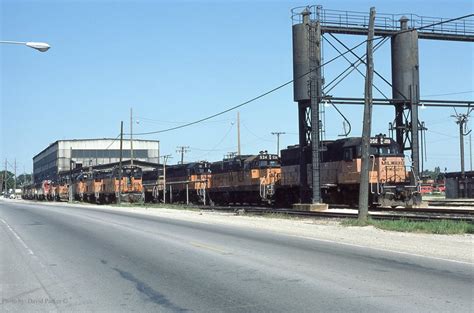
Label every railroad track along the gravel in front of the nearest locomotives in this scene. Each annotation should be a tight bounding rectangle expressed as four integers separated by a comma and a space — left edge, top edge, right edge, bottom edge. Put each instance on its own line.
199, 206, 474, 223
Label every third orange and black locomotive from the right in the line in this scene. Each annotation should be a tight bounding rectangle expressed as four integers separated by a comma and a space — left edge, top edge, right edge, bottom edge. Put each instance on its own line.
166, 161, 211, 205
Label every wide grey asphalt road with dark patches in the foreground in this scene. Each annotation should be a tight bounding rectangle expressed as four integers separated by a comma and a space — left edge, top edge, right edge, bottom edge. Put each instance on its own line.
0, 201, 474, 312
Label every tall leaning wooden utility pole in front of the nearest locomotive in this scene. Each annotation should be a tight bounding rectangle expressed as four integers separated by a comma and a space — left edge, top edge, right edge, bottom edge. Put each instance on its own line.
359, 7, 375, 222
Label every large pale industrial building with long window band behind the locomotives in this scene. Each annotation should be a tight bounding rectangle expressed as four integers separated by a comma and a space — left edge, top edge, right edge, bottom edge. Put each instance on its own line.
33, 139, 160, 183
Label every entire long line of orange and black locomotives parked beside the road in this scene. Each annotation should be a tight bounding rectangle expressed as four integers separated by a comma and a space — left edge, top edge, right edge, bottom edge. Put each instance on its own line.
23, 135, 421, 207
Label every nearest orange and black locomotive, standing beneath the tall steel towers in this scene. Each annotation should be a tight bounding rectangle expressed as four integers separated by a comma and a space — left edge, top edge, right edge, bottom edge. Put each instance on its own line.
278, 135, 421, 207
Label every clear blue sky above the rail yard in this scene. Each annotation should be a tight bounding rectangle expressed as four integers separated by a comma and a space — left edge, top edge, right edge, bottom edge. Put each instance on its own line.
0, 0, 474, 171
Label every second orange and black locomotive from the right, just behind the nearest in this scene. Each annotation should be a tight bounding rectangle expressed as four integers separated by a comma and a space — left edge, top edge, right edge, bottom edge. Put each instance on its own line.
208, 151, 281, 205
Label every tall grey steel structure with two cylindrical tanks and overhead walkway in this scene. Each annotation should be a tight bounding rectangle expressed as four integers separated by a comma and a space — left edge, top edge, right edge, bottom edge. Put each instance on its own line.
291, 5, 474, 202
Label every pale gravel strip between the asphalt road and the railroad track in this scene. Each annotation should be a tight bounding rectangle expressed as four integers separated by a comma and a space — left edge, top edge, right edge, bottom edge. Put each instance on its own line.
0, 199, 474, 265
